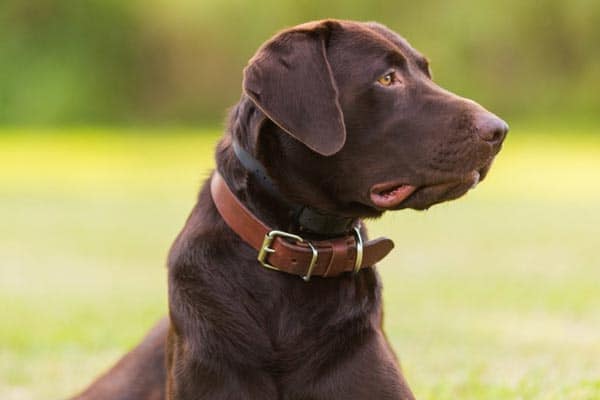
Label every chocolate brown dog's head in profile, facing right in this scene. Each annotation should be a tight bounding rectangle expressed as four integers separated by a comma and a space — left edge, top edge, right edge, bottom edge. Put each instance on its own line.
243, 20, 508, 217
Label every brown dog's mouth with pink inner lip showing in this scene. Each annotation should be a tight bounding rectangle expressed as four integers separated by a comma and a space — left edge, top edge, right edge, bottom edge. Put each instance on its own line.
369, 165, 489, 211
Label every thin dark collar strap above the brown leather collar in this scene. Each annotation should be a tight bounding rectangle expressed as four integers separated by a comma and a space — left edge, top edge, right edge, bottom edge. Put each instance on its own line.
233, 140, 356, 236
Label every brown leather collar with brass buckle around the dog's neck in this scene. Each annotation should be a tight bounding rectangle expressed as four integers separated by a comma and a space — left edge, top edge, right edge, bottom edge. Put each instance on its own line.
210, 171, 394, 281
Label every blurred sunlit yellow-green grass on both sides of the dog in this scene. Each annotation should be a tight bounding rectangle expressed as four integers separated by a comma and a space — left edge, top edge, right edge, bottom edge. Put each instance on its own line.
0, 126, 600, 400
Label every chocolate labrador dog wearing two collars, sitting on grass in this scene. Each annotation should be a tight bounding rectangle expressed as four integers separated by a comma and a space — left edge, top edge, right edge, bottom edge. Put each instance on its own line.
74, 20, 508, 400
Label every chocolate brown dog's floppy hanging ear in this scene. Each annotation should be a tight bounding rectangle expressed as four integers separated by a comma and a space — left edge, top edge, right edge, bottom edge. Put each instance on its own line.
243, 21, 346, 156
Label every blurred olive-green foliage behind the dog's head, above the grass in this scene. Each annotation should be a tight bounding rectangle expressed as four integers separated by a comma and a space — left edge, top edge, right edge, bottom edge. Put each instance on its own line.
0, 0, 600, 125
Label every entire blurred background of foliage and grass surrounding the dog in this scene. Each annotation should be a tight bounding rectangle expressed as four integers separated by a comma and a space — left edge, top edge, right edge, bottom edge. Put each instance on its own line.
0, 0, 600, 400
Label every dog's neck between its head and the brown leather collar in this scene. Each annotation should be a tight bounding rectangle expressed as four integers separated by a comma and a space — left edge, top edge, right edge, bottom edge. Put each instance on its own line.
216, 97, 357, 238
